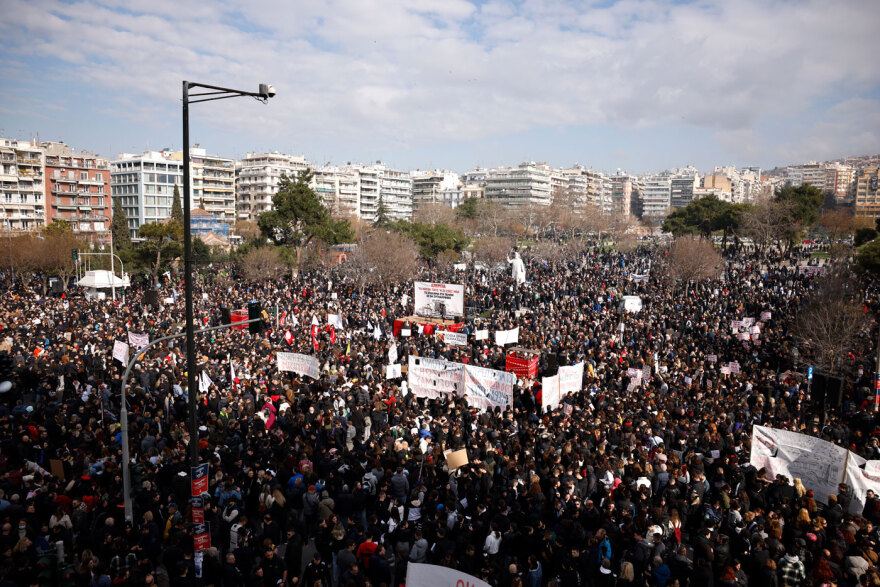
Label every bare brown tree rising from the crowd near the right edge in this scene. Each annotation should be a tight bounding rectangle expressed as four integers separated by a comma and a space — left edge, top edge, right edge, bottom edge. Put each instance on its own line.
793, 267, 868, 373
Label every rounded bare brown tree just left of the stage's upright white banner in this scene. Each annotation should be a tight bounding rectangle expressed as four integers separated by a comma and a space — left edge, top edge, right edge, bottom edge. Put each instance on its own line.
342, 229, 419, 292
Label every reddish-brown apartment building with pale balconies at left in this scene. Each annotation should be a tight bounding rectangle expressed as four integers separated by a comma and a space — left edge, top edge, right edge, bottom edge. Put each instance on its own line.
41, 142, 113, 242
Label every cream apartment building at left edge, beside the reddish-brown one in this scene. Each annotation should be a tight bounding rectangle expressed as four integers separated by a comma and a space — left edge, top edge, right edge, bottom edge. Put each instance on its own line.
0, 138, 46, 230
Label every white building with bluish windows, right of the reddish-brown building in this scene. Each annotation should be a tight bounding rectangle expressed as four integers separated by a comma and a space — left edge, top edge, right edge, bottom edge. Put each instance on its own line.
110, 151, 183, 237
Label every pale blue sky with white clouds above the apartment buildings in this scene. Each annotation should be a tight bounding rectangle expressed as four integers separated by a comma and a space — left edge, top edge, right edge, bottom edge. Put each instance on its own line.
0, 0, 880, 173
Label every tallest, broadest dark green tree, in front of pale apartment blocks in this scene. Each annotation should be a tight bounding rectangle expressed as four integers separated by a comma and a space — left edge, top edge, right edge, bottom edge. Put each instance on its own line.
257, 169, 354, 251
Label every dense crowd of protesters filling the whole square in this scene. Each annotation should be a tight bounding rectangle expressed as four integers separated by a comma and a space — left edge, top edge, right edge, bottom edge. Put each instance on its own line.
0, 240, 880, 587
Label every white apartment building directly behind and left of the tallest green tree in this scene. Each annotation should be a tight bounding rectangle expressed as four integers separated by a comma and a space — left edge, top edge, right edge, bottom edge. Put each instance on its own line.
235, 152, 310, 222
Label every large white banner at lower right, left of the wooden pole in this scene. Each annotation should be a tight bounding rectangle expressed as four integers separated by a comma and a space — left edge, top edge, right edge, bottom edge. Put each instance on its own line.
749, 426, 848, 503
